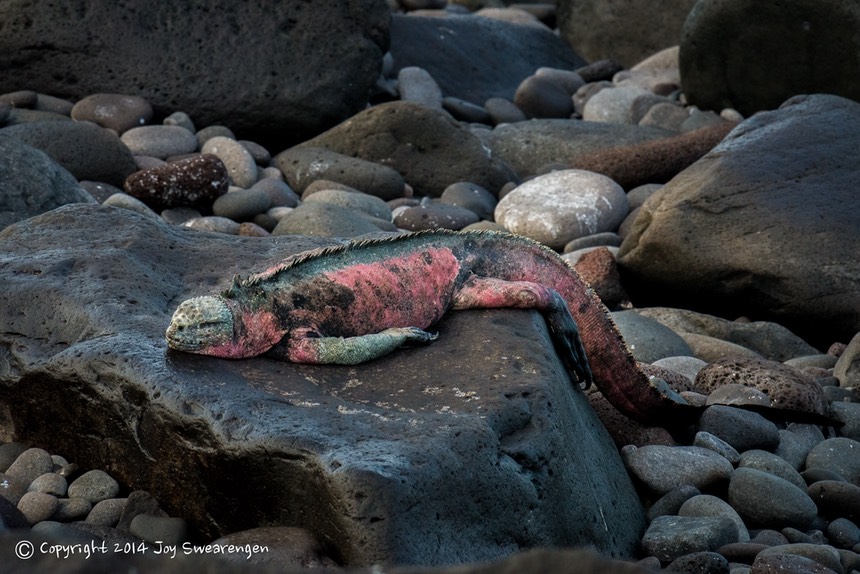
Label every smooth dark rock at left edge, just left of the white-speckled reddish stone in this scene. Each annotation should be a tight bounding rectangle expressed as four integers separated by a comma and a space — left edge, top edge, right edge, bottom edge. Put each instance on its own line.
2, 122, 137, 186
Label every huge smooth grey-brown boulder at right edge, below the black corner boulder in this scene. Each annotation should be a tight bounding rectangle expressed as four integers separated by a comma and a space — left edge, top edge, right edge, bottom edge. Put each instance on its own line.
619, 95, 860, 348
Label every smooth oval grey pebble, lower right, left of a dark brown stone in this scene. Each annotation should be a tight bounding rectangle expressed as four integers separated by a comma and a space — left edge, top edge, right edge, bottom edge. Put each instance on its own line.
728, 468, 818, 529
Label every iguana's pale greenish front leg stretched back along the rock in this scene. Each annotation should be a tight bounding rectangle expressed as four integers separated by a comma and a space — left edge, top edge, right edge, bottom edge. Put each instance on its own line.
270, 327, 438, 365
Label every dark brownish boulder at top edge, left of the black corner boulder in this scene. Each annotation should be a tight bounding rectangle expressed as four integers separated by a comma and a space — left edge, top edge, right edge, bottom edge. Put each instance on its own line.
558, 0, 696, 67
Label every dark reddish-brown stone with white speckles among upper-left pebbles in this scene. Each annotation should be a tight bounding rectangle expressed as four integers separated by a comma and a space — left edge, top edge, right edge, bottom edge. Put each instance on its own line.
124, 154, 230, 208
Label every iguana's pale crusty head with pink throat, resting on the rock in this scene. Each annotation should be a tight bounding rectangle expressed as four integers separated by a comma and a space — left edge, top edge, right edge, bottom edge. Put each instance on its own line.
165, 296, 283, 359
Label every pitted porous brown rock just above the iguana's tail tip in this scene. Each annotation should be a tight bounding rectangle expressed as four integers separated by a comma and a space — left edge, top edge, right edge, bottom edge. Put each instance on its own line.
696, 358, 829, 417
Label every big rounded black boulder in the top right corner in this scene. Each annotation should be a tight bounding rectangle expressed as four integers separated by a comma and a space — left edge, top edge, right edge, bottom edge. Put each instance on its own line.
679, 0, 860, 116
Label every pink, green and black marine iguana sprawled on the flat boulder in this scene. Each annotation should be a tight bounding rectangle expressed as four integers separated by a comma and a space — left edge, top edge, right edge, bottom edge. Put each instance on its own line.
166, 230, 685, 422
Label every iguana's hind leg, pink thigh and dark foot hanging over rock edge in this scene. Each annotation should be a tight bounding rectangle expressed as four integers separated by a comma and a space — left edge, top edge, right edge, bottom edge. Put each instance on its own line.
453, 275, 593, 387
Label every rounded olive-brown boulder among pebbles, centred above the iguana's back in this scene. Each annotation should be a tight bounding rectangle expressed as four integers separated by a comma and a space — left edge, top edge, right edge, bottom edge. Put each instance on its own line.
302, 102, 516, 197
